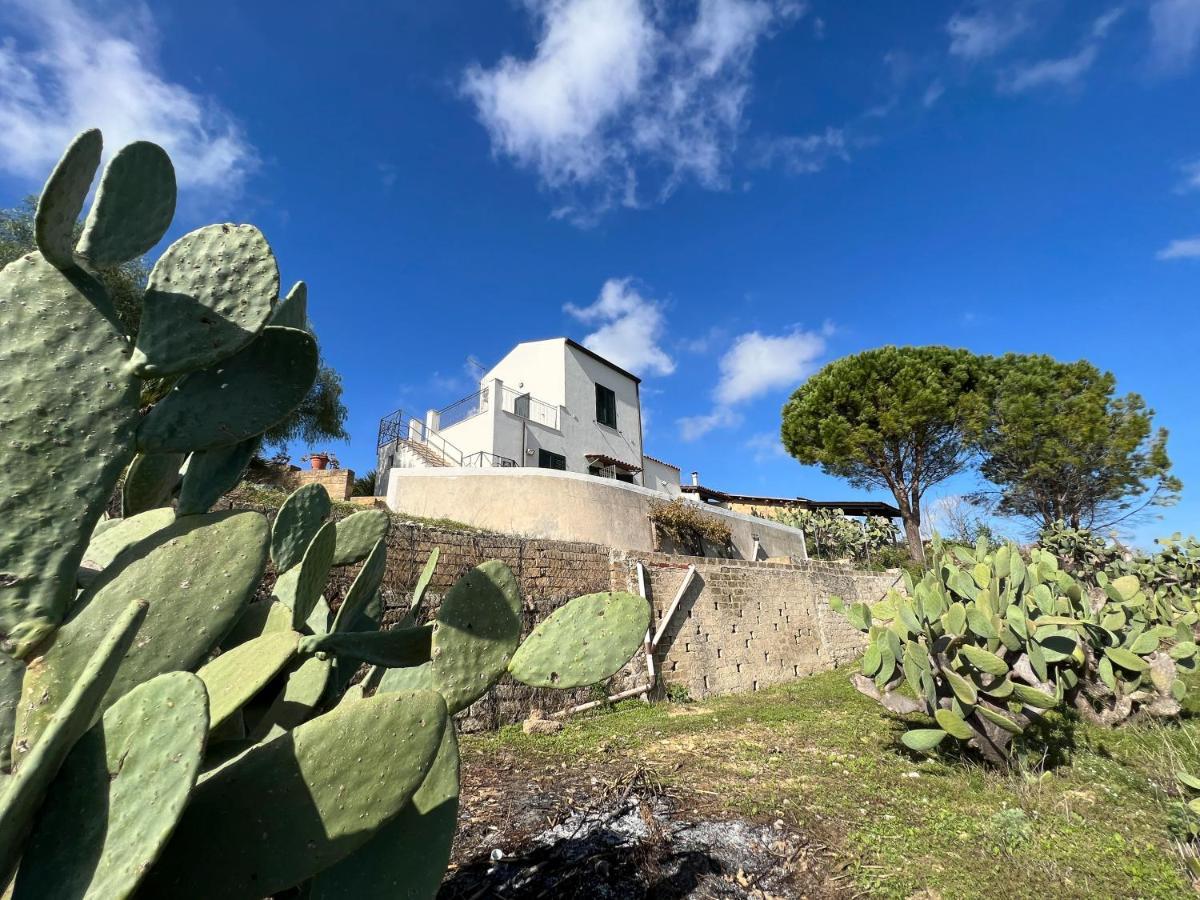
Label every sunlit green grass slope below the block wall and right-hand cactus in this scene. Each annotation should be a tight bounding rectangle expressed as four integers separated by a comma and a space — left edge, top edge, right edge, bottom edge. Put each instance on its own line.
463, 671, 1200, 900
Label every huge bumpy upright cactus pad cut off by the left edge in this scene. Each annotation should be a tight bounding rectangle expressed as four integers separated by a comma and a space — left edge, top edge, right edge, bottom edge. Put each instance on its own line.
0, 253, 138, 658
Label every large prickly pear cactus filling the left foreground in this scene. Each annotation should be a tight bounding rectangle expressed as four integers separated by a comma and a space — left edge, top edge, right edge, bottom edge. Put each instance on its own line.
0, 131, 649, 900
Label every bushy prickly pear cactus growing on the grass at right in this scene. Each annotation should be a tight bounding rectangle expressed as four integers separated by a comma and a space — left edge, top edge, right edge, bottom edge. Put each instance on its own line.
833, 541, 1200, 766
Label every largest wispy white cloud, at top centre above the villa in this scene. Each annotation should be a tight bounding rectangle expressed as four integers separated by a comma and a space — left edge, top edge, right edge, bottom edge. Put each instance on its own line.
462, 0, 802, 221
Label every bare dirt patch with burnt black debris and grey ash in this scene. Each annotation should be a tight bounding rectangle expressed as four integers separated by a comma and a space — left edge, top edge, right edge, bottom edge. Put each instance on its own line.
438, 754, 845, 900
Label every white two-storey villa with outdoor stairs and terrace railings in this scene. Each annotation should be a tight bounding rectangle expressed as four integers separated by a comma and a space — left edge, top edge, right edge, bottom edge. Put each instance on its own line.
376, 337, 679, 497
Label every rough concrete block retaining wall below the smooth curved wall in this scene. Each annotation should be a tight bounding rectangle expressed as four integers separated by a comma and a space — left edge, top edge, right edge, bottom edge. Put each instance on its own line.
225, 508, 899, 732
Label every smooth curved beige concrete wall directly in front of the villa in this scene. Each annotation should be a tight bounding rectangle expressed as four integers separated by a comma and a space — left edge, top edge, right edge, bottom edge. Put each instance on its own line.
388, 468, 808, 559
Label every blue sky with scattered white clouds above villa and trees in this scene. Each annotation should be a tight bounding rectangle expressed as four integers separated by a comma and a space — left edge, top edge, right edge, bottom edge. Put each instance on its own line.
0, 0, 1200, 542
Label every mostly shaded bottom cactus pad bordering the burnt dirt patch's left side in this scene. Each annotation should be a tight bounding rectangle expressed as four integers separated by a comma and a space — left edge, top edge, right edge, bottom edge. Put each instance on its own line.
308, 726, 458, 900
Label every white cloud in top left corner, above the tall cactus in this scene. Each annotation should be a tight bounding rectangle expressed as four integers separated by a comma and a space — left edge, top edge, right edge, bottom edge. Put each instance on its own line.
0, 0, 257, 193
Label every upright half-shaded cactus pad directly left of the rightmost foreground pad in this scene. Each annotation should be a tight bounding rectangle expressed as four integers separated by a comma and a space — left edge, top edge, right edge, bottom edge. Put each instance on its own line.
432, 559, 521, 714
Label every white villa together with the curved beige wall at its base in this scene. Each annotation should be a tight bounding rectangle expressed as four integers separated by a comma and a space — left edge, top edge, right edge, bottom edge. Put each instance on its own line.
376, 337, 890, 559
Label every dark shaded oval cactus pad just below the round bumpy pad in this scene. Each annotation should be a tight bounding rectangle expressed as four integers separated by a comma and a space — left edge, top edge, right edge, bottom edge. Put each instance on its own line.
137, 328, 317, 454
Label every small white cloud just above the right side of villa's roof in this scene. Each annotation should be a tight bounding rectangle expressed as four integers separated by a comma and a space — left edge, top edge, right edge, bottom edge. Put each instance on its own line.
563, 278, 674, 376
